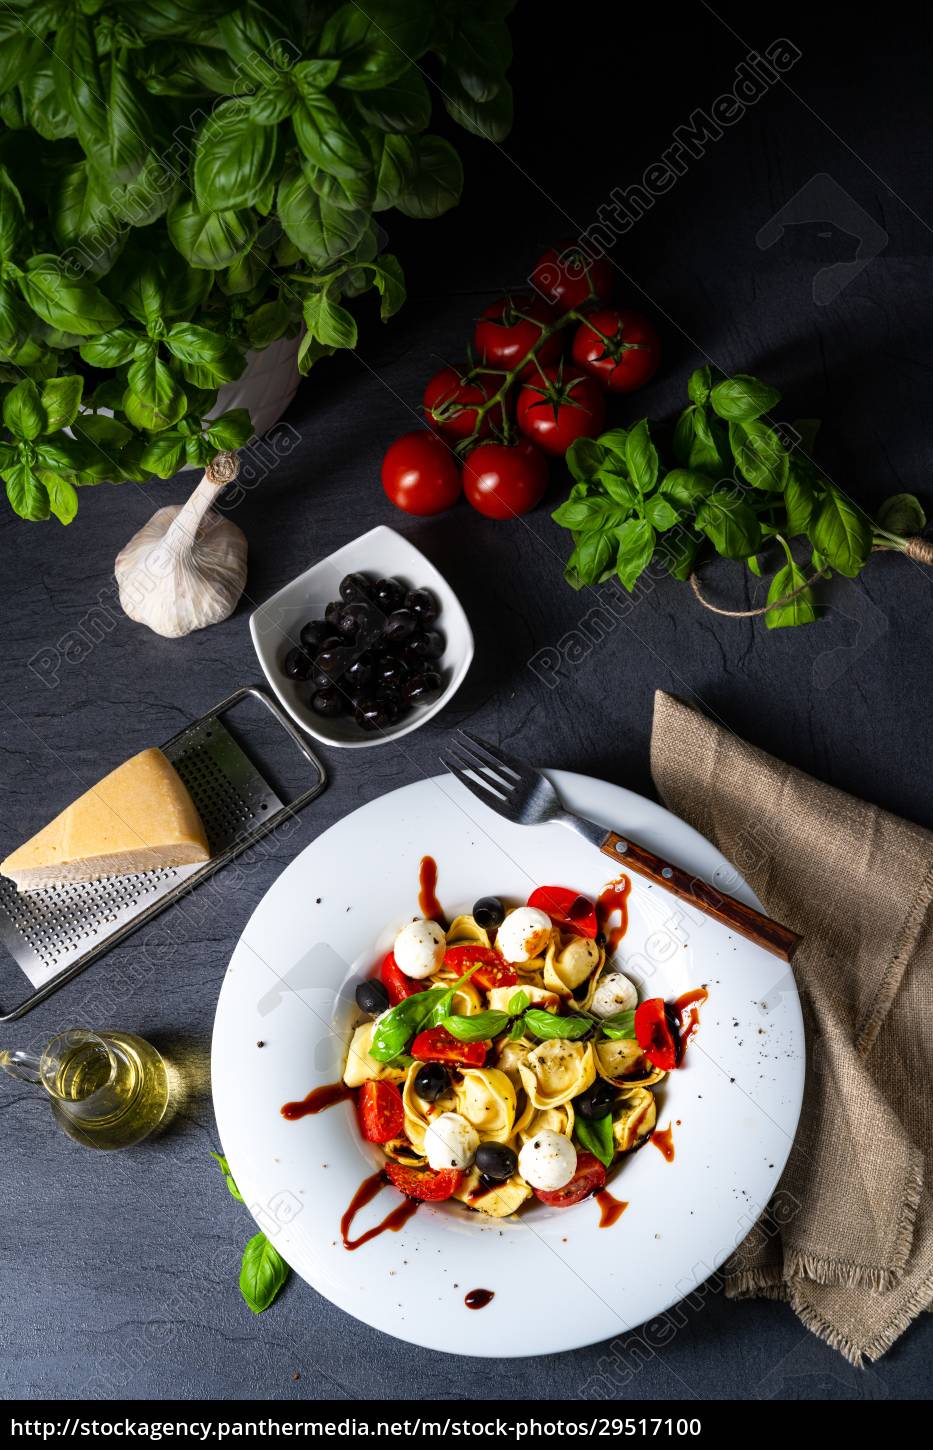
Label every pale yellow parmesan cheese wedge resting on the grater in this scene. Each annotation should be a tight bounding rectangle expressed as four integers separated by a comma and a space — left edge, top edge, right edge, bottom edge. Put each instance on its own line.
0, 750, 210, 892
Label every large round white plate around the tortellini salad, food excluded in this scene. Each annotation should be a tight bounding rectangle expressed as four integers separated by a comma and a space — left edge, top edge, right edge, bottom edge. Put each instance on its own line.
212, 771, 804, 1357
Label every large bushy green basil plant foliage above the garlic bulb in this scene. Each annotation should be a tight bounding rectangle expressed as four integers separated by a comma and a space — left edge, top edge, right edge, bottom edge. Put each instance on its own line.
0, 0, 512, 523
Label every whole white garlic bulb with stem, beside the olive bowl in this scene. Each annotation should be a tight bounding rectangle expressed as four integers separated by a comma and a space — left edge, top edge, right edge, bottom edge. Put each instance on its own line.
113, 452, 247, 639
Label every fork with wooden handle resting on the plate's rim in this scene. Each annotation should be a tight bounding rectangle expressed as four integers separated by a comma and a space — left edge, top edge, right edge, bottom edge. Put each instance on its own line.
441, 731, 800, 961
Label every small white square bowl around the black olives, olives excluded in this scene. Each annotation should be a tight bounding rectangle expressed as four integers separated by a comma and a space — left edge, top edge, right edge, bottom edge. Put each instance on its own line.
250, 523, 473, 750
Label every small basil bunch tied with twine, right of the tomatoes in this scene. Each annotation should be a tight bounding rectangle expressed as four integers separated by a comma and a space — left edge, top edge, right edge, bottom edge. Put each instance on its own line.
553, 367, 926, 629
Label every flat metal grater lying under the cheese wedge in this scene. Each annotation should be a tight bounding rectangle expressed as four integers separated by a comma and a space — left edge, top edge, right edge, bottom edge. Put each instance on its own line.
0, 686, 326, 1022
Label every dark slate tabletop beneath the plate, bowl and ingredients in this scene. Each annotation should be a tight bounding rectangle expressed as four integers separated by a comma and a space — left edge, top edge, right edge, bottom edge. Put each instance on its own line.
0, 6, 933, 1399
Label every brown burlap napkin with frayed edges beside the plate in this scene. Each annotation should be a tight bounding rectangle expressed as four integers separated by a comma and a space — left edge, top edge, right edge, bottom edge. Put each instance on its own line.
652, 692, 933, 1364
